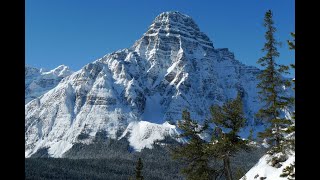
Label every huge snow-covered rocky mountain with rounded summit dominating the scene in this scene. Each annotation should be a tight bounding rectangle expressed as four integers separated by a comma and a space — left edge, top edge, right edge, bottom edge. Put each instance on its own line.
25, 12, 278, 157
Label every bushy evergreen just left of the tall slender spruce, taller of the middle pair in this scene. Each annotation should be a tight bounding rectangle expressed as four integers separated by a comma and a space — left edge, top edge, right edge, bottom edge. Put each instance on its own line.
210, 93, 249, 180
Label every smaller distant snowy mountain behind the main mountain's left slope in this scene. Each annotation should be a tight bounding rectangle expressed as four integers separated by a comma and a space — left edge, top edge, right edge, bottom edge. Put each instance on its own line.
25, 65, 73, 104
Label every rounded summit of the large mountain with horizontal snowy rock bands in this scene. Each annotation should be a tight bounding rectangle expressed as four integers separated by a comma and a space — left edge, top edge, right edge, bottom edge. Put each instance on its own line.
133, 11, 214, 59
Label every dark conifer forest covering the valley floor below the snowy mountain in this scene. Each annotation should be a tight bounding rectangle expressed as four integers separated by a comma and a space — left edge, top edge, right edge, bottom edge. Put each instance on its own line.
25, 133, 266, 180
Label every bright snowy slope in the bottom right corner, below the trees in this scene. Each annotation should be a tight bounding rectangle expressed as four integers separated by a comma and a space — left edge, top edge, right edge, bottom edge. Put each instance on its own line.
240, 152, 295, 180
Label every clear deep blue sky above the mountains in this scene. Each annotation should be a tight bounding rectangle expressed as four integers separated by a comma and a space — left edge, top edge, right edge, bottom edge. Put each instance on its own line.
25, 0, 295, 76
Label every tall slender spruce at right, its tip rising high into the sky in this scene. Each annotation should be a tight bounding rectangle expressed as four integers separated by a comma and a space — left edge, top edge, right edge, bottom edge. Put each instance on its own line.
256, 10, 292, 151
